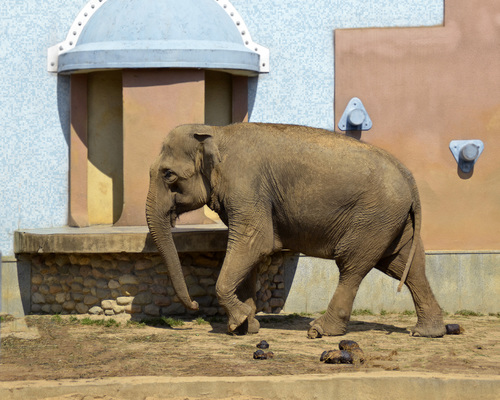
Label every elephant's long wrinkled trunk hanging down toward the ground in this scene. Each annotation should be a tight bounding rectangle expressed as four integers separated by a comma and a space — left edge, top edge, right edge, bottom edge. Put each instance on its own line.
146, 176, 199, 310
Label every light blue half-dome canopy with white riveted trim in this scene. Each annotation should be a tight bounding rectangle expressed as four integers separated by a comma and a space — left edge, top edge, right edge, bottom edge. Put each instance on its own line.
49, 0, 269, 75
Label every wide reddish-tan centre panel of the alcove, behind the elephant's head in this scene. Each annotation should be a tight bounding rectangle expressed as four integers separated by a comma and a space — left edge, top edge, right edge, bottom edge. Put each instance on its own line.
117, 69, 205, 225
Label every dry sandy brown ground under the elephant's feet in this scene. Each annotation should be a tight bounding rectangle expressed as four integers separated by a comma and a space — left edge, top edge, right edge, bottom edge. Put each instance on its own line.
0, 314, 500, 399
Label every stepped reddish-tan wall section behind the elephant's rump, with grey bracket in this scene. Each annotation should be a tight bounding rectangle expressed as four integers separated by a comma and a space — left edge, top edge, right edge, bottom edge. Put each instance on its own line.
335, 0, 500, 250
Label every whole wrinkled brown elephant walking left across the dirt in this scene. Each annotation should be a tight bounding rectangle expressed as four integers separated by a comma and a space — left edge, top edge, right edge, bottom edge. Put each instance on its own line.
146, 123, 445, 337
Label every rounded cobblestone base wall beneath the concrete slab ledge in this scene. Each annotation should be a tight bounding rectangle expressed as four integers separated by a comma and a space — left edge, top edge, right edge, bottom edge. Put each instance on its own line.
18, 252, 285, 317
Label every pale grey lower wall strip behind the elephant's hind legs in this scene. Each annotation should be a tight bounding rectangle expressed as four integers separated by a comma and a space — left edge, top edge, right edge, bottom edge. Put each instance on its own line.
283, 252, 500, 314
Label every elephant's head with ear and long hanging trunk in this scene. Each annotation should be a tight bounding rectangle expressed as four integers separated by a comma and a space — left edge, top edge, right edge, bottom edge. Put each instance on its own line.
146, 125, 220, 310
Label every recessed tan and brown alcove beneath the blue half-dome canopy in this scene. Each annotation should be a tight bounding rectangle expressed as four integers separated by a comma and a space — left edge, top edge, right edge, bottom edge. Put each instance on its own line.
69, 69, 248, 227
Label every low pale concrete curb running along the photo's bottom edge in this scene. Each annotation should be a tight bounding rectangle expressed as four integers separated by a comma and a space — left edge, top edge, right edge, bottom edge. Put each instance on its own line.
0, 372, 500, 400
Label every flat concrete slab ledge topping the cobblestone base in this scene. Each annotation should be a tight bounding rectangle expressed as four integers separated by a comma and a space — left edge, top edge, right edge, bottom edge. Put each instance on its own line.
14, 224, 227, 254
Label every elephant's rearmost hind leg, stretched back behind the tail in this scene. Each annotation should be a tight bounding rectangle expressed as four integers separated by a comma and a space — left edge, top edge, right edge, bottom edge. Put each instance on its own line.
376, 238, 446, 337
